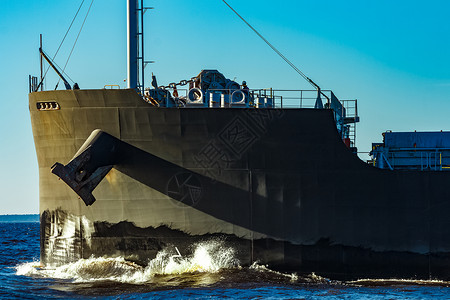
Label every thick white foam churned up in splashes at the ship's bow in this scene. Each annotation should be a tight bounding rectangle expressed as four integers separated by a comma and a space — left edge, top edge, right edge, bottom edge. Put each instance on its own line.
16, 241, 239, 284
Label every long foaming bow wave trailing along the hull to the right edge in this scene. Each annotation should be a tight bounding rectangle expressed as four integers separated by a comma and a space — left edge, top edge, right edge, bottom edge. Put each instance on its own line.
16, 240, 450, 287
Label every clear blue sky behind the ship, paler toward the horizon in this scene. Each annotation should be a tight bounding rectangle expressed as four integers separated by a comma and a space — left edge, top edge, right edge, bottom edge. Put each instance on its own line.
0, 0, 450, 214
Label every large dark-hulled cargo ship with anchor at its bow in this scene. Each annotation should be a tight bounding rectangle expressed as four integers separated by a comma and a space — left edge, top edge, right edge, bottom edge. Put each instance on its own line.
29, 0, 450, 280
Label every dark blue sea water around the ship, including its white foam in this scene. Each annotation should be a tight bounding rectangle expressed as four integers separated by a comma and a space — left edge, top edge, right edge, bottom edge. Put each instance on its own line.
0, 217, 450, 299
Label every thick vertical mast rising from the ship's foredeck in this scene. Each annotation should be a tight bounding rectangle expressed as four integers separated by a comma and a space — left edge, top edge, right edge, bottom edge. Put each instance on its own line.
127, 0, 139, 89
